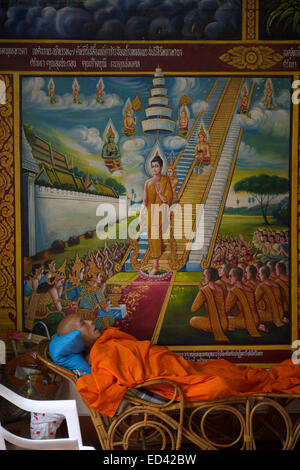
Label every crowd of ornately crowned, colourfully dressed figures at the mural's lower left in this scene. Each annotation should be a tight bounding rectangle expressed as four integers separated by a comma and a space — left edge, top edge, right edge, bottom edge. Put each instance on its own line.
24, 243, 127, 335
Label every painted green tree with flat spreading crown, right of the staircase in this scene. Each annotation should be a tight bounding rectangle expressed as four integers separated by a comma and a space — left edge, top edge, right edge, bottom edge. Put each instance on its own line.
233, 174, 289, 225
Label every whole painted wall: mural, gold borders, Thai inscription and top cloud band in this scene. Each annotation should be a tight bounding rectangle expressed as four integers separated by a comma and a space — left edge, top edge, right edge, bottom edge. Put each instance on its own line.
0, 0, 300, 364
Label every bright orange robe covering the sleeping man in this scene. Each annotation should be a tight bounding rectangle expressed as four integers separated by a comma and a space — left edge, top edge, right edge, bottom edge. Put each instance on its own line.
76, 327, 300, 417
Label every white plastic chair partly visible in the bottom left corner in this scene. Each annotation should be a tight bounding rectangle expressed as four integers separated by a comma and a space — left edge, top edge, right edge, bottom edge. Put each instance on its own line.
0, 384, 95, 450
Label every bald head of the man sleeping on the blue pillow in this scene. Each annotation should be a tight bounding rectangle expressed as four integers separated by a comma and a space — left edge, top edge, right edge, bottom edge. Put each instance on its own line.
57, 313, 101, 350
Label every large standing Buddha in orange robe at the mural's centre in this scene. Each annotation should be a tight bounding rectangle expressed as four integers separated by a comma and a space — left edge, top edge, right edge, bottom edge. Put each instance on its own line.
139, 154, 173, 276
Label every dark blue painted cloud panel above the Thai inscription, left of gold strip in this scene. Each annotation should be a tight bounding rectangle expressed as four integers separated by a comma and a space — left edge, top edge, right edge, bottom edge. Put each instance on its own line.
0, 0, 241, 41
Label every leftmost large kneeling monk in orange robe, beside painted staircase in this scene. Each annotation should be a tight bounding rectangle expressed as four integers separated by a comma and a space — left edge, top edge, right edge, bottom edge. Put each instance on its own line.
190, 268, 229, 343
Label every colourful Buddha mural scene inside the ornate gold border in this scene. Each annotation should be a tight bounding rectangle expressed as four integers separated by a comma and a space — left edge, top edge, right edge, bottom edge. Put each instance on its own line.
21, 70, 291, 358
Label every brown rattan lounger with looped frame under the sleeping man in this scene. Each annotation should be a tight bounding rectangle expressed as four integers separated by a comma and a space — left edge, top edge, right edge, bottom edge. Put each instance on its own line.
38, 340, 300, 450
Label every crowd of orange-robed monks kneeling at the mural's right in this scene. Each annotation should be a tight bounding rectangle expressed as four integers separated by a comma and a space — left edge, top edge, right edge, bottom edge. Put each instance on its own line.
190, 230, 289, 341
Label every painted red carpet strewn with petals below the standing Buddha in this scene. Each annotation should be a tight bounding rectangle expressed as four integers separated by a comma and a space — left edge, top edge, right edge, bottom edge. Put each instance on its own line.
115, 277, 170, 340
